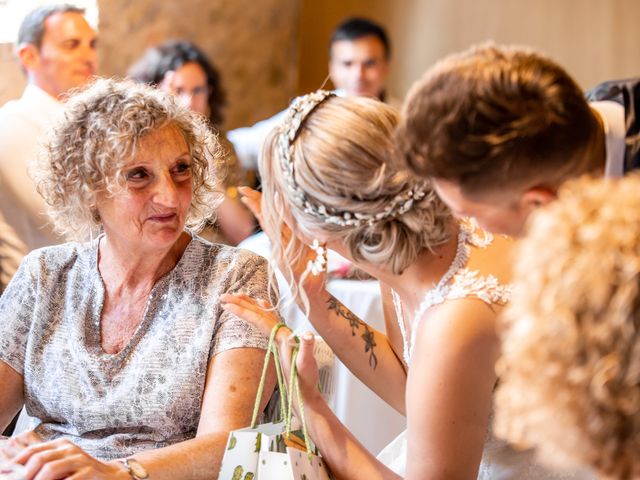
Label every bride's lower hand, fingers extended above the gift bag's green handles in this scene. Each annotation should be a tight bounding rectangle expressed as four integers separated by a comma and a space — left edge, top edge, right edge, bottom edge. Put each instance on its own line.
220, 293, 320, 401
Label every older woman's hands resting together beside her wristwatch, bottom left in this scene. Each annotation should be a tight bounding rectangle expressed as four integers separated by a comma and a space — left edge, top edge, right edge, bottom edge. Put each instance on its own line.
3, 432, 131, 480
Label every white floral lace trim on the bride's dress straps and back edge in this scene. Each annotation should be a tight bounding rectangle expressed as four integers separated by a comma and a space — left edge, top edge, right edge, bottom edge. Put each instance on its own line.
392, 219, 510, 365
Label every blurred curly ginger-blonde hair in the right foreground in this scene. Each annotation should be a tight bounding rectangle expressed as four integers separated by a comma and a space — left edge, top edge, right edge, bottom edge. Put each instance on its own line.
496, 176, 640, 479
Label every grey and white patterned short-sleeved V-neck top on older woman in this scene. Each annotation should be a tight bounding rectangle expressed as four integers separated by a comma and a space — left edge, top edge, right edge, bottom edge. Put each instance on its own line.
0, 235, 268, 460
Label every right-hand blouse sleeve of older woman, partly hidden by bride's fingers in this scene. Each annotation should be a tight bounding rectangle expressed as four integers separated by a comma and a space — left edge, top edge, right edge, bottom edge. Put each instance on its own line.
211, 250, 274, 357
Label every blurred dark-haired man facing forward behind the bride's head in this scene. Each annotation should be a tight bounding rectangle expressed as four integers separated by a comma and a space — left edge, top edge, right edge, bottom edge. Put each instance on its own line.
227, 17, 392, 170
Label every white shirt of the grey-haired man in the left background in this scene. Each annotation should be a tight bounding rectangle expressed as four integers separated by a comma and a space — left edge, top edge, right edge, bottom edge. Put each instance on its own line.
0, 85, 62, 289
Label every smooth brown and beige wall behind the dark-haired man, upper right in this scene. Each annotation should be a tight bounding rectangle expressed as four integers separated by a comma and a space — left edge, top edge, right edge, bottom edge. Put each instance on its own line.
298, 0, 640, 98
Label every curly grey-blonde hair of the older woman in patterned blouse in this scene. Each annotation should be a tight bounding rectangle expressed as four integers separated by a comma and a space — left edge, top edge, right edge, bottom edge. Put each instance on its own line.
34, 79, 225, 240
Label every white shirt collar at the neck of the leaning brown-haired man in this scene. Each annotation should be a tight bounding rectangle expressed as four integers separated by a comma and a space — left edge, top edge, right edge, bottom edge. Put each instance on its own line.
589, 100, 626, 178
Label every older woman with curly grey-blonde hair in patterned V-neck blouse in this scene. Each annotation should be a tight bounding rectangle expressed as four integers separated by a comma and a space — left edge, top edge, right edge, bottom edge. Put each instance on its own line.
0, 80, 273, 479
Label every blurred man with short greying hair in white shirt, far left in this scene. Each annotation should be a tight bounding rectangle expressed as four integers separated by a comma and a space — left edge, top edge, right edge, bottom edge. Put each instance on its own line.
0, 5, 97, 292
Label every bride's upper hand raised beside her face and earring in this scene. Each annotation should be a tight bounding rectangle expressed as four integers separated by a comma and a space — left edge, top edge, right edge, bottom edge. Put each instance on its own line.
238, 187, 326, 296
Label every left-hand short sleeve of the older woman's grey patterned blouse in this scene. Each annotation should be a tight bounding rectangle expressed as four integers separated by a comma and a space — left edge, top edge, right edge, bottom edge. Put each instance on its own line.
0, 253, 38, 375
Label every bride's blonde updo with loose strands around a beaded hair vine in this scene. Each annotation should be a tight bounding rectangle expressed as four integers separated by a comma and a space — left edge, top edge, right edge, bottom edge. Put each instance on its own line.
260, 97, 452, 308
